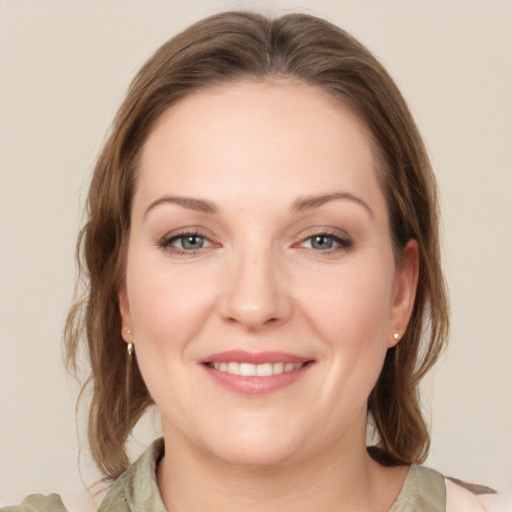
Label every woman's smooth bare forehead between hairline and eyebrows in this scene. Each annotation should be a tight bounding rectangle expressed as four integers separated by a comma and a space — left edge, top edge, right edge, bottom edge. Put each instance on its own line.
136, 81, 386, 217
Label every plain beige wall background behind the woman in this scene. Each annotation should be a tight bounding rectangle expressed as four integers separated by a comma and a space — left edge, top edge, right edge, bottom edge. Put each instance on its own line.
0, 0, 512, 511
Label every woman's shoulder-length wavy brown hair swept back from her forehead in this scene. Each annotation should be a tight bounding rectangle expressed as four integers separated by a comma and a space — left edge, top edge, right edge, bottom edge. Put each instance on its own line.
65, 12, 448, 480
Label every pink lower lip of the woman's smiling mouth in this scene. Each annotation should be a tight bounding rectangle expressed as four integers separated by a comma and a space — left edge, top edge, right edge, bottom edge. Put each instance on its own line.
201, 363, 312, 395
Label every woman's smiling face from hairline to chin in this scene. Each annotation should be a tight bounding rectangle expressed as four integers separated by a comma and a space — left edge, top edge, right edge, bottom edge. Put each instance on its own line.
119, 82, 417, 465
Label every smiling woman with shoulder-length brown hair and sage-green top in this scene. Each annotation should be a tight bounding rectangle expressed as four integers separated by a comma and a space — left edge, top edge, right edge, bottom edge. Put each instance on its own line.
4, 13, 506, 512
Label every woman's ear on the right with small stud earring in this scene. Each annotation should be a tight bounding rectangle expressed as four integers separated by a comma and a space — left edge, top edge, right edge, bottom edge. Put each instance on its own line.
388, 240, 420, 347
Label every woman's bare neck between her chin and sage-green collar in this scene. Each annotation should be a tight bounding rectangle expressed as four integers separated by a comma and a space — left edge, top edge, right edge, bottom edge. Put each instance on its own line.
157, 424, 406, 512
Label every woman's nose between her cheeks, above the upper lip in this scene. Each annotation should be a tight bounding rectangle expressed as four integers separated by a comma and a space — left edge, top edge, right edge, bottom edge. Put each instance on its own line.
219, 247, 293, 331
